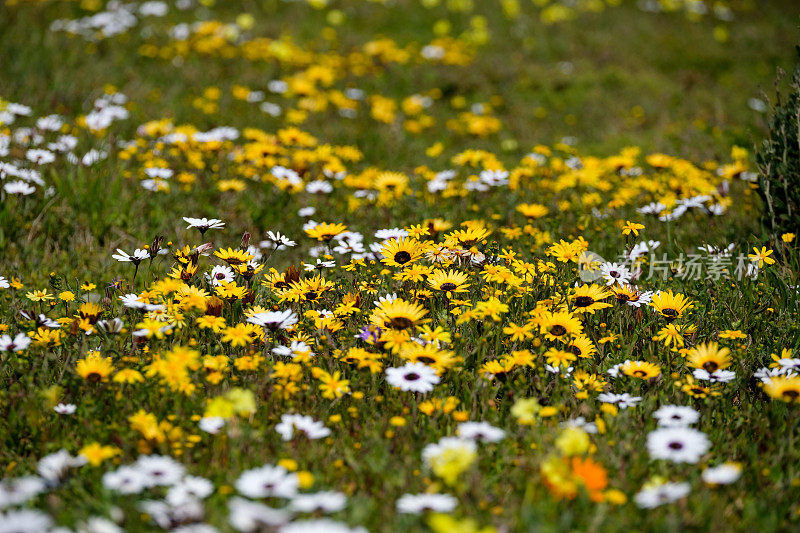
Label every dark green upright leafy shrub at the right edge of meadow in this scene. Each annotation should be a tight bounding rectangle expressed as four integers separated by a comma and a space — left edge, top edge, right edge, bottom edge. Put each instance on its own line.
756, 47, 800, 233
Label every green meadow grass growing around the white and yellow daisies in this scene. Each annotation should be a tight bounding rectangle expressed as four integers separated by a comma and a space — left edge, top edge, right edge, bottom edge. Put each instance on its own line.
0, 0, 800, 533
